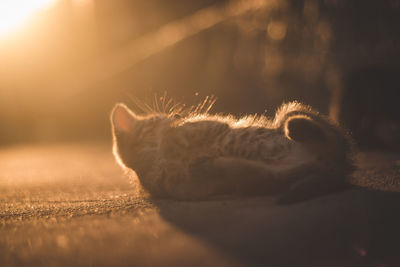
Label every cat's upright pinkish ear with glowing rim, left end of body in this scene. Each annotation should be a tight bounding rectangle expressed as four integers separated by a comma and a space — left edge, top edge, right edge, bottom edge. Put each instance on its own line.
111, 103, 137, 132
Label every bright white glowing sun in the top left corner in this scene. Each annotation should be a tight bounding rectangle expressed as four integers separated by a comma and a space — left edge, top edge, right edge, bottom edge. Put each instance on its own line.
0, 0, 56, 37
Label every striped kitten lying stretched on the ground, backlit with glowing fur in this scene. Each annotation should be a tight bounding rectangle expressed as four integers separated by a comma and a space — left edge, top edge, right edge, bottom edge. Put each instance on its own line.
111, 102, 352, 203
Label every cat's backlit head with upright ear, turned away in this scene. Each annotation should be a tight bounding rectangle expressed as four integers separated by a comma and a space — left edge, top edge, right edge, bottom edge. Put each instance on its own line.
111, 104, 176, 174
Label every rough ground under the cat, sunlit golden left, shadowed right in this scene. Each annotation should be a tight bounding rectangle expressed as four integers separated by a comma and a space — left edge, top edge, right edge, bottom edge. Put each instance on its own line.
0, 144, 400, 267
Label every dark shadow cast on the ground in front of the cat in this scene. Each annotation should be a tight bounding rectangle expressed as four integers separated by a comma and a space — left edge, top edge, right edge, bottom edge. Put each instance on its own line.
157, 190, 400, 266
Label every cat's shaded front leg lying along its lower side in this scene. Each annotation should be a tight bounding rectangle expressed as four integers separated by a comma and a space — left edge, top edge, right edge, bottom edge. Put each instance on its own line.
189, 157, 287, 198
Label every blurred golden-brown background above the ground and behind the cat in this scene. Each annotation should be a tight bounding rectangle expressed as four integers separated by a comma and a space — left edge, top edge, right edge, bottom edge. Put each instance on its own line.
0, 0, 400, 150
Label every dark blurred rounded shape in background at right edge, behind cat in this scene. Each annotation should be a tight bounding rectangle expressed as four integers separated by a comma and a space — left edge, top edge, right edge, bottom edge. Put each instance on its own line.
340, 66, 400, 151
